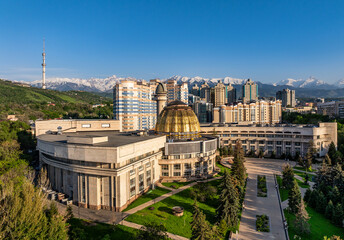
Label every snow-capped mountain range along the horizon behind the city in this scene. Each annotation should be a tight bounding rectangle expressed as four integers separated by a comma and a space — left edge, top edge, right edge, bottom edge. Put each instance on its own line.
30, 75, 344, 92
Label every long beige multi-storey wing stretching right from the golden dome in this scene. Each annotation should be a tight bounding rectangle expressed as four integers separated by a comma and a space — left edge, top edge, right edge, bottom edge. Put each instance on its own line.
201, 122, 337, 157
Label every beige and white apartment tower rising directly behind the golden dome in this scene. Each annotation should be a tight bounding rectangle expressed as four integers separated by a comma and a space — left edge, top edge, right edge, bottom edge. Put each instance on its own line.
166, 79, 189, 104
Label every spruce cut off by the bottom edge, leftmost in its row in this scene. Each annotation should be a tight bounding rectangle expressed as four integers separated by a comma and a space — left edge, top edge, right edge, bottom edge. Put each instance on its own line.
190, 200, 211, 240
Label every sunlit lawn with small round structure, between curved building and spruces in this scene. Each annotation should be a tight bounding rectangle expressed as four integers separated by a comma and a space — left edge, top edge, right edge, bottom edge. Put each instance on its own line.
126, 180, 221, 238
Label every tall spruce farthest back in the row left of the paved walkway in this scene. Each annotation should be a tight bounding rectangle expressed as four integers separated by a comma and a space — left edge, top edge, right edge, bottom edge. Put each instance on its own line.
231, 141, 246, 187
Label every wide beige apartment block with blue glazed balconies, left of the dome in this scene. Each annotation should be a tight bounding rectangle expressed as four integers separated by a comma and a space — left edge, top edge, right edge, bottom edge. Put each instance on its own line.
113, 80, 159, 131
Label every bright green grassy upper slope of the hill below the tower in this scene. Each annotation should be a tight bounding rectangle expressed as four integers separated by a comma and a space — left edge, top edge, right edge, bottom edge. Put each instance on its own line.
0, 80, 111, 104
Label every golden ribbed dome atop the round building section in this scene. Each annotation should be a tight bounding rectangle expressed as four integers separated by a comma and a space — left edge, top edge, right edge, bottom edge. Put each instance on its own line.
155, 101, 201, 139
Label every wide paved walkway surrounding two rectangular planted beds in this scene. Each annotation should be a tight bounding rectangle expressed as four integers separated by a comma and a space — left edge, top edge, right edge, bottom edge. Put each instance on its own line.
234, 158, 286, 240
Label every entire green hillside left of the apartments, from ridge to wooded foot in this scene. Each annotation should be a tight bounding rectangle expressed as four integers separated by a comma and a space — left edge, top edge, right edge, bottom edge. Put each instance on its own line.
0, 80, 112, 122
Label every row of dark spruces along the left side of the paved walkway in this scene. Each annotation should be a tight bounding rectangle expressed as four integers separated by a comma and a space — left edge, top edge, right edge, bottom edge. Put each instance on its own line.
191, 141, 246, 240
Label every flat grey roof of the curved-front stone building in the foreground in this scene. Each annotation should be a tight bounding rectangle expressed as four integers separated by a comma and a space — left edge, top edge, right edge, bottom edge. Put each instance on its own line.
37, 131, 163, 147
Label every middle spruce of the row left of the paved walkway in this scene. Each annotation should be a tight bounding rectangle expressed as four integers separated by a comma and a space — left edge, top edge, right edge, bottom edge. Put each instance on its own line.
216, 171, 239, 227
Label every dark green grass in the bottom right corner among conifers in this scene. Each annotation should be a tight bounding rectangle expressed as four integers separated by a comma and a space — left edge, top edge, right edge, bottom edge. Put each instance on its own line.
284, 207, 344, 240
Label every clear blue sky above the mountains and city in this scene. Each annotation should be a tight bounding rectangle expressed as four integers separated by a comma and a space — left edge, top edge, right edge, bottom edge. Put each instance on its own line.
0, 0, 344, 83
